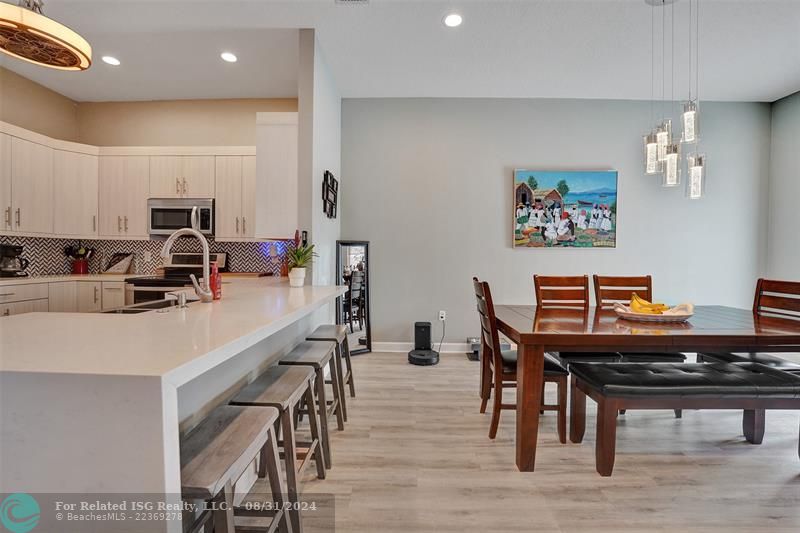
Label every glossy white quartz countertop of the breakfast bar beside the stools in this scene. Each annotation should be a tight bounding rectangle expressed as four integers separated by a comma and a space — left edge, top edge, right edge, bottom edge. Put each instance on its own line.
0, 276, 346, 386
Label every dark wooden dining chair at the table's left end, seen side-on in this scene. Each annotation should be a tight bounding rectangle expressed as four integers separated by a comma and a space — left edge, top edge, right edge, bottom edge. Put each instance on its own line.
472, 278, 569, 444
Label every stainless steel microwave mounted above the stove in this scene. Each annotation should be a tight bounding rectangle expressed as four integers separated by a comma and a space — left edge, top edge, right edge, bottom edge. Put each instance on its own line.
147, 198, 214, 236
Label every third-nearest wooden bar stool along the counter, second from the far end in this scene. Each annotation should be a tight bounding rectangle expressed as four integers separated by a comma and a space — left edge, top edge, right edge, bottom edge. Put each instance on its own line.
280, 341, 344, 467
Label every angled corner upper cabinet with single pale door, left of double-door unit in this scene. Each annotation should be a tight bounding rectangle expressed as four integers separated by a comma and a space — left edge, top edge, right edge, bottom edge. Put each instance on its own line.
53, 150, 98, 237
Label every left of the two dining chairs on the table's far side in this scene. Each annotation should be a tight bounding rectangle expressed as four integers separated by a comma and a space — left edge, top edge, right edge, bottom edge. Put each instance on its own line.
533, 274, 622, 368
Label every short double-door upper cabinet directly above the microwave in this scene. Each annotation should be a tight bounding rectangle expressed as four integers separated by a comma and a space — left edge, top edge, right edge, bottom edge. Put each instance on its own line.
150, 155, 214, 198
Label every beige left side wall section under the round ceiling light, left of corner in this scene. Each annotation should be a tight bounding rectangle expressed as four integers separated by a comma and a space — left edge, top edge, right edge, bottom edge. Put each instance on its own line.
0, 67, 78, 141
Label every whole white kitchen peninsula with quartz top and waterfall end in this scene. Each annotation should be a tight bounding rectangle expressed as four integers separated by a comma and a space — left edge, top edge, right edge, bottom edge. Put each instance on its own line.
0, 278, 345, 531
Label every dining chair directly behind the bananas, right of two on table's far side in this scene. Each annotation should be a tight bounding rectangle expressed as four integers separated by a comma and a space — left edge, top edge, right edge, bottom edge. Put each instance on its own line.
593, 274, 686, 418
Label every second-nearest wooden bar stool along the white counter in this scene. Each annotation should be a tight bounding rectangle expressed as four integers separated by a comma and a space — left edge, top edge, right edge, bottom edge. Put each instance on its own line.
230, 366, 325, 533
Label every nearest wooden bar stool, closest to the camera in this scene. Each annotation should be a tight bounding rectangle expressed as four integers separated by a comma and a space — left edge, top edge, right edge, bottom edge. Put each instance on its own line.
180, 405, 290, 533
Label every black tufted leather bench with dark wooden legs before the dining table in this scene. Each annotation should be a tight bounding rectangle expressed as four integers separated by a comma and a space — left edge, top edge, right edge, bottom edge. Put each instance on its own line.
569, 363, 800, 476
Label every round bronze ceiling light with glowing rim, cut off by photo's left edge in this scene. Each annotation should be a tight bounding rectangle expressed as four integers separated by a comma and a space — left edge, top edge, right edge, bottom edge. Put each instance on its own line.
0, 0, 92, 70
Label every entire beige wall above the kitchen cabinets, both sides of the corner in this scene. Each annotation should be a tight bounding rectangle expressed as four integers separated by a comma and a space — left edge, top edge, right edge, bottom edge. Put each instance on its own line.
0, 67, 297, 146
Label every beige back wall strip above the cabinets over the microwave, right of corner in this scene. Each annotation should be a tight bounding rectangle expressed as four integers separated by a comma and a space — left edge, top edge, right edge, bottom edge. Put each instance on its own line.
78, 98, 297, 146
